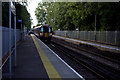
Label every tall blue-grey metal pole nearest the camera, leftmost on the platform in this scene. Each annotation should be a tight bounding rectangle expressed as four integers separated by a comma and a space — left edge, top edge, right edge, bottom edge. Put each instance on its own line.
9, 0, 12, 78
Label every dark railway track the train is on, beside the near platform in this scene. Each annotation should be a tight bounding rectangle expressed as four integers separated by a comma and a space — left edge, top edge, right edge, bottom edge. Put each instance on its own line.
44, 42, 120, 80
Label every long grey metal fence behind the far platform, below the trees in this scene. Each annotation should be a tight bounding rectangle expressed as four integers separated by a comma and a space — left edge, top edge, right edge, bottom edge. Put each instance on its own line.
55, 31, 120, 46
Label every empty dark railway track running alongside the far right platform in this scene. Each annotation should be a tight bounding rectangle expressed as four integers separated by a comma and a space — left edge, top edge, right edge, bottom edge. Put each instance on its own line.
52, 37, 120, 64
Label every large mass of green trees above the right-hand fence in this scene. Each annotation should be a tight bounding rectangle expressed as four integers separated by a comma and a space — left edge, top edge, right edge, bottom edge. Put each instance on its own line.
35, 2, 120, 31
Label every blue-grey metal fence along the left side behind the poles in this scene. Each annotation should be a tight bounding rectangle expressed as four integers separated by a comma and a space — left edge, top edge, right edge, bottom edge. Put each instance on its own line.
0, 27, 21, 57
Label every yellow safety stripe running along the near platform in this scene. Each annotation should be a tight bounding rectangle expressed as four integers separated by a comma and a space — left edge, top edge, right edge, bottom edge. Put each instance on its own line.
31, 34, 62, 80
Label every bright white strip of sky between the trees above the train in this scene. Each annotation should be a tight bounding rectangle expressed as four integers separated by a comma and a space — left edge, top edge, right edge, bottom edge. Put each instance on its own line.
27, 0, 41, 26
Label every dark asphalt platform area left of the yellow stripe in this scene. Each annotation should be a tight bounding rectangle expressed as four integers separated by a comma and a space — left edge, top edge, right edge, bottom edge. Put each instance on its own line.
2, 36, 48, 80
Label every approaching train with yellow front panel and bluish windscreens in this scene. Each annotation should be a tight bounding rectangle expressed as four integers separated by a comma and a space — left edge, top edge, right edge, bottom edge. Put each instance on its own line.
34, 25, 52, 41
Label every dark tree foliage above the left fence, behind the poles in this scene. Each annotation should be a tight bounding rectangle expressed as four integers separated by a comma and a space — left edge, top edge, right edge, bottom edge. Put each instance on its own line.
2, 2, 31, 29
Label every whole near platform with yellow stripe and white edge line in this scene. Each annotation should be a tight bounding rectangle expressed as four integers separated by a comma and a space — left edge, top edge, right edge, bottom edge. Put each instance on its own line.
2, 34, 85, 80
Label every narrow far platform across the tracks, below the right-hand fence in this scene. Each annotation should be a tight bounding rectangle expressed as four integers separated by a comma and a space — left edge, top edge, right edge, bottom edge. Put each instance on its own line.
53, 35, 120, 53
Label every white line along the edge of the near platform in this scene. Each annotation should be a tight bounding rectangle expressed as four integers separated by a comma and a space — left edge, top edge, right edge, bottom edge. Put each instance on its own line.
38, 38, 85, 80
